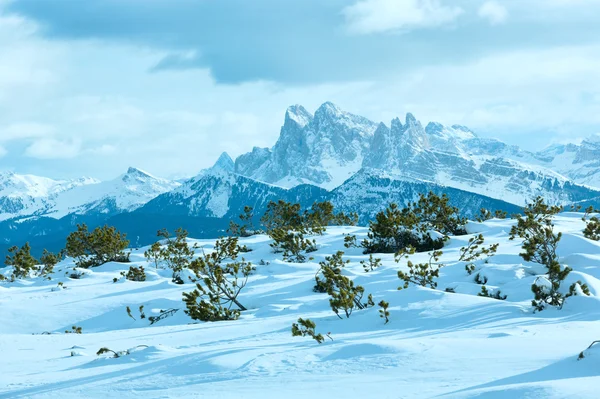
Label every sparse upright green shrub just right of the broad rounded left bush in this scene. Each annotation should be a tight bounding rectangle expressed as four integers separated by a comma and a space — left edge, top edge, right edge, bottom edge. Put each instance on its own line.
144, 228, 198, 284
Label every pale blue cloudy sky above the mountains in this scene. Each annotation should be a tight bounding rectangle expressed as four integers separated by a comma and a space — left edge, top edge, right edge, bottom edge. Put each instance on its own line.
0, 0, 600, 179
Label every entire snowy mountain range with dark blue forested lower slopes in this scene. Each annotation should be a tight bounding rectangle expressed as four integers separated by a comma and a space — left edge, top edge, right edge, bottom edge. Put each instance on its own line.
0, 102, 600, 256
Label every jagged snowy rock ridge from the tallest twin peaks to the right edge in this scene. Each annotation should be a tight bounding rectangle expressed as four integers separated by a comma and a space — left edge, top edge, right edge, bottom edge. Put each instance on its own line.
235, 103, 600, 205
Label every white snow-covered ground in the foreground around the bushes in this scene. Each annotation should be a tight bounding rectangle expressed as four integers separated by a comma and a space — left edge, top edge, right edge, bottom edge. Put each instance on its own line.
0, 213, 600, 399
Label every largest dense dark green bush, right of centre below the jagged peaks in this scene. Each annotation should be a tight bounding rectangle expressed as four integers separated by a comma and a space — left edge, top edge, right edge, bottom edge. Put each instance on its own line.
362, 192, 467, 253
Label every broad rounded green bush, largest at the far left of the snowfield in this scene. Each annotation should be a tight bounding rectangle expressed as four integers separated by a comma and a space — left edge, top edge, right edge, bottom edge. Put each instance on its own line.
66, 224, 129, 268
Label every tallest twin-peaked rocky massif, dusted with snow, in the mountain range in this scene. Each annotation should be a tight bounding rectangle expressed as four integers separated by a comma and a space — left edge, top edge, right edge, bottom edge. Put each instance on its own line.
235, 102, 377, 189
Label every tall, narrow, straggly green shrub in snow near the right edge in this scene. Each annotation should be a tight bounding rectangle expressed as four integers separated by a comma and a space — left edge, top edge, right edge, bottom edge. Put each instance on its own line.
510, 197, 589, 311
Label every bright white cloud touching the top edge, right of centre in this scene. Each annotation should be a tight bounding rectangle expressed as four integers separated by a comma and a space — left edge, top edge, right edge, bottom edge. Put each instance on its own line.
343, 0, 463, 34
